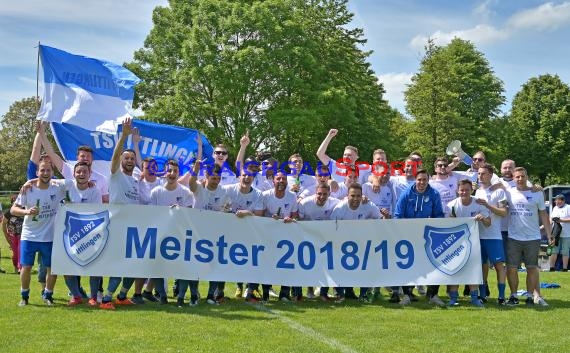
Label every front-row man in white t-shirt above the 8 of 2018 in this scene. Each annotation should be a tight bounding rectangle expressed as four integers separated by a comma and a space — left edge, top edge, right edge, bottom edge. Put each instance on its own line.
330, 183, 380, 302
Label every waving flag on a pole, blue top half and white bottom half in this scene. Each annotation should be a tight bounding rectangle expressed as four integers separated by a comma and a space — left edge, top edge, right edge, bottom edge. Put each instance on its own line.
37, 45, 140, 133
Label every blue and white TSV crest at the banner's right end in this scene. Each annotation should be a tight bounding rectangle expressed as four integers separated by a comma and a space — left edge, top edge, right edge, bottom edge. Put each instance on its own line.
424, 224, 471, 276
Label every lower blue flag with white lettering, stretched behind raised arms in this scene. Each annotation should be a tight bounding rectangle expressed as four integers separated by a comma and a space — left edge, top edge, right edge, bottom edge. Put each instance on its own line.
51, 120, 214, 176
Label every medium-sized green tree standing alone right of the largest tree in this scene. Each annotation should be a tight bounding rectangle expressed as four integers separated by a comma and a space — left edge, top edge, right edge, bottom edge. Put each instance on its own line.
404, 38, 505, 161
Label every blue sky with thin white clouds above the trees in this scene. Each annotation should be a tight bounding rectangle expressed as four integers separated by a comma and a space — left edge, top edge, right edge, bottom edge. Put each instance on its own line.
0, 0, 570, 119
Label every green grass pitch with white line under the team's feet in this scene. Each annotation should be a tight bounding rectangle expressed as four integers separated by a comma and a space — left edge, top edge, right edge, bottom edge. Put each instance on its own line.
0, 228, 570, 353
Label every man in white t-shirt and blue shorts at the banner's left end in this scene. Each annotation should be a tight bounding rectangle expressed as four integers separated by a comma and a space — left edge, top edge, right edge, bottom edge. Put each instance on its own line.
10, 160, 65, 306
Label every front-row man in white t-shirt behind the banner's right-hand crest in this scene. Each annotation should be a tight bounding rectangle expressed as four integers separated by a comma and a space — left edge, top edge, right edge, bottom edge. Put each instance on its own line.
446, 179, 491, 308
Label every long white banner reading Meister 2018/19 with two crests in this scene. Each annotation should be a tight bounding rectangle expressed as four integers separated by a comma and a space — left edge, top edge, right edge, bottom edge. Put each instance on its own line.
52, 204, 482, 287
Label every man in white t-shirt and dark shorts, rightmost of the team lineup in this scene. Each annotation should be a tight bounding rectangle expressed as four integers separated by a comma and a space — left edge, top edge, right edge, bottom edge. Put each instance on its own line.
507, 167, 554, 306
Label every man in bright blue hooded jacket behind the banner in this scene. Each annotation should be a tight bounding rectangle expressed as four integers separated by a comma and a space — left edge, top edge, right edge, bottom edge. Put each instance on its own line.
394, 169, 445, 306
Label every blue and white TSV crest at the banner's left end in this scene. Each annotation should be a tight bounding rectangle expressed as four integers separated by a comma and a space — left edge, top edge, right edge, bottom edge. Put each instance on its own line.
63, 211, 109, 266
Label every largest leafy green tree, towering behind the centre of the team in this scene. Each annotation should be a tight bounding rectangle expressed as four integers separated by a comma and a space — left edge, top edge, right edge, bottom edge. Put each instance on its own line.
127, 0, 392, 164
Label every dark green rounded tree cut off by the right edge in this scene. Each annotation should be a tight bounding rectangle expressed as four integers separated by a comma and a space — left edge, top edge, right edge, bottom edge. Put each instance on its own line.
505, 74, 570, 185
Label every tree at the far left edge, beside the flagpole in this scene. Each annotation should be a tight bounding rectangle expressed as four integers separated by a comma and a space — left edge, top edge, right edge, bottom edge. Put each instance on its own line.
0, 97, 39, 190
